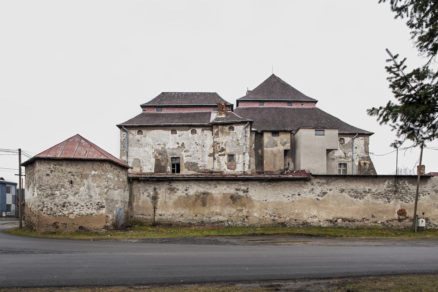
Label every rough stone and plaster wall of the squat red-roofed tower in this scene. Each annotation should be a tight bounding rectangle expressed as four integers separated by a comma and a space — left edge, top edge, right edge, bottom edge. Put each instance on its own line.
25, 160, 129, 231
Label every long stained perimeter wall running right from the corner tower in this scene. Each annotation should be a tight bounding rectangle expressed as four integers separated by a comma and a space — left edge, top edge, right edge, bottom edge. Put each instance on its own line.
131, 176, 438, 227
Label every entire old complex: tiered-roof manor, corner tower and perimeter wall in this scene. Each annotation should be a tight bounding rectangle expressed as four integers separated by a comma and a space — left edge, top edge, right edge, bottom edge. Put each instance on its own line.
22, 75, 438, 232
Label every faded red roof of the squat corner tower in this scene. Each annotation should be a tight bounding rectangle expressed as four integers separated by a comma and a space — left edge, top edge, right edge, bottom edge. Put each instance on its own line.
23, 134, 129, 168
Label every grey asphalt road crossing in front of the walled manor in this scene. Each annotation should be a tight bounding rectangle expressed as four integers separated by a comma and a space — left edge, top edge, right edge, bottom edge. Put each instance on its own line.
0, 224, 438, 287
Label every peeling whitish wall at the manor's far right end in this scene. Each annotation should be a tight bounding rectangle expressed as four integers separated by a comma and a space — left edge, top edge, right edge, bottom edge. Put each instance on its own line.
327, 135, 376, 175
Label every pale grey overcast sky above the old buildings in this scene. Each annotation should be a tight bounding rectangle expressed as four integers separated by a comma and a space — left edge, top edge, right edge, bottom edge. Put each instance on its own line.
0, 0, 438, 181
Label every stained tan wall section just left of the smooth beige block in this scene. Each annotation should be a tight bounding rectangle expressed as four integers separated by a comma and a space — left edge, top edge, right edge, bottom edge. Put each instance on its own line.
263, 132, 294, 172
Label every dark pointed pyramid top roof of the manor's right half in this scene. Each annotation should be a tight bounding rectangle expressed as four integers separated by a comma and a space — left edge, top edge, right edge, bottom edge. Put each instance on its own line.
238, 74, 317, 102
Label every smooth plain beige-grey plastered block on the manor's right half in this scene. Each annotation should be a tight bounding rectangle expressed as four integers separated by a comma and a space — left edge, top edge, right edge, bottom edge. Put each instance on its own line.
294, 129, 338, 174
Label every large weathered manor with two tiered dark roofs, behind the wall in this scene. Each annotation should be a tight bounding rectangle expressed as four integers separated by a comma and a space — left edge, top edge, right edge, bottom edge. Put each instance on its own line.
118, 74, 376, 175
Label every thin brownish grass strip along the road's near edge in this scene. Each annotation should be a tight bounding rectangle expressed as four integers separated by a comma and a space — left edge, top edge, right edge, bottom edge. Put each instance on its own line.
0, 274, 438, 292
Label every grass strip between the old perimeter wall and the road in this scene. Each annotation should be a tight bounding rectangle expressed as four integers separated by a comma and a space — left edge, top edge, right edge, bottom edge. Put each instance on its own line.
3, 225, 438, 240
